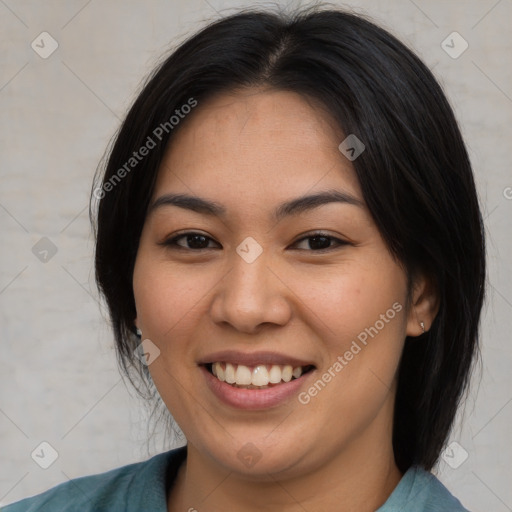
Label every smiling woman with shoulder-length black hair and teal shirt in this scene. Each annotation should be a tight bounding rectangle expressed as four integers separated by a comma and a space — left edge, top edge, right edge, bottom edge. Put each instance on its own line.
5, 4, 485, 512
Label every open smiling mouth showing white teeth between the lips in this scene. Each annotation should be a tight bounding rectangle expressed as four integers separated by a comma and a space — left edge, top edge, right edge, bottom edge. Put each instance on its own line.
204, 361, 315, 389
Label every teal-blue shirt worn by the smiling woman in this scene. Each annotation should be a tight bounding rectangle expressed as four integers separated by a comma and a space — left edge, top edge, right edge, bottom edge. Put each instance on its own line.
1, 447, 469, 512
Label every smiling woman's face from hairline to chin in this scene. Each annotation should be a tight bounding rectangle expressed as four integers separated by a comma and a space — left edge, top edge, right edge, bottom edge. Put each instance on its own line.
133, 89, 419, 478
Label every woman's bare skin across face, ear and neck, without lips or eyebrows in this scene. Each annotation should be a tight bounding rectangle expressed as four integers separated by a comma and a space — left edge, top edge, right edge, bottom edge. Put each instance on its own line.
133, 89, 437, 512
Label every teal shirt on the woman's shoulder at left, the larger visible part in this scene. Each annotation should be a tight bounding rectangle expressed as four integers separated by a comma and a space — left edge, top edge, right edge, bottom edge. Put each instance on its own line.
1, 447, 186, 512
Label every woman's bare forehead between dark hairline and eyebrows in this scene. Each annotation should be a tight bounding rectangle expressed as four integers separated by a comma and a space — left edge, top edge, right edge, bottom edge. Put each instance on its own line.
155, 89, 361, 204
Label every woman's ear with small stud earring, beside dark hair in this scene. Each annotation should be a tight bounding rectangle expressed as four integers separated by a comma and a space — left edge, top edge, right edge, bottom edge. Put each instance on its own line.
406, 273, 439, 337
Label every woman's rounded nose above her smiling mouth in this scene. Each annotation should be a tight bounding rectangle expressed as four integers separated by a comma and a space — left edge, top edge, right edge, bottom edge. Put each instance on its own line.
211, 249, 292, 334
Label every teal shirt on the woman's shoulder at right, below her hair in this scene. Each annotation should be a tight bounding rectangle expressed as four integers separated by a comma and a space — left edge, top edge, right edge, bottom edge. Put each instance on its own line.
377, 466, 469, 512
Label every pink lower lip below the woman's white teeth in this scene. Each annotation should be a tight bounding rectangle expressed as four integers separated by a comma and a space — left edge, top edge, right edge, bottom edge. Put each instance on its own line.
200, 366, 314, 409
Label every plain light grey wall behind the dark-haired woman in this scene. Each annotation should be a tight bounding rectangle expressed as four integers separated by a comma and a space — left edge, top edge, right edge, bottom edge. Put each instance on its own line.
0, 0, 512, 512
